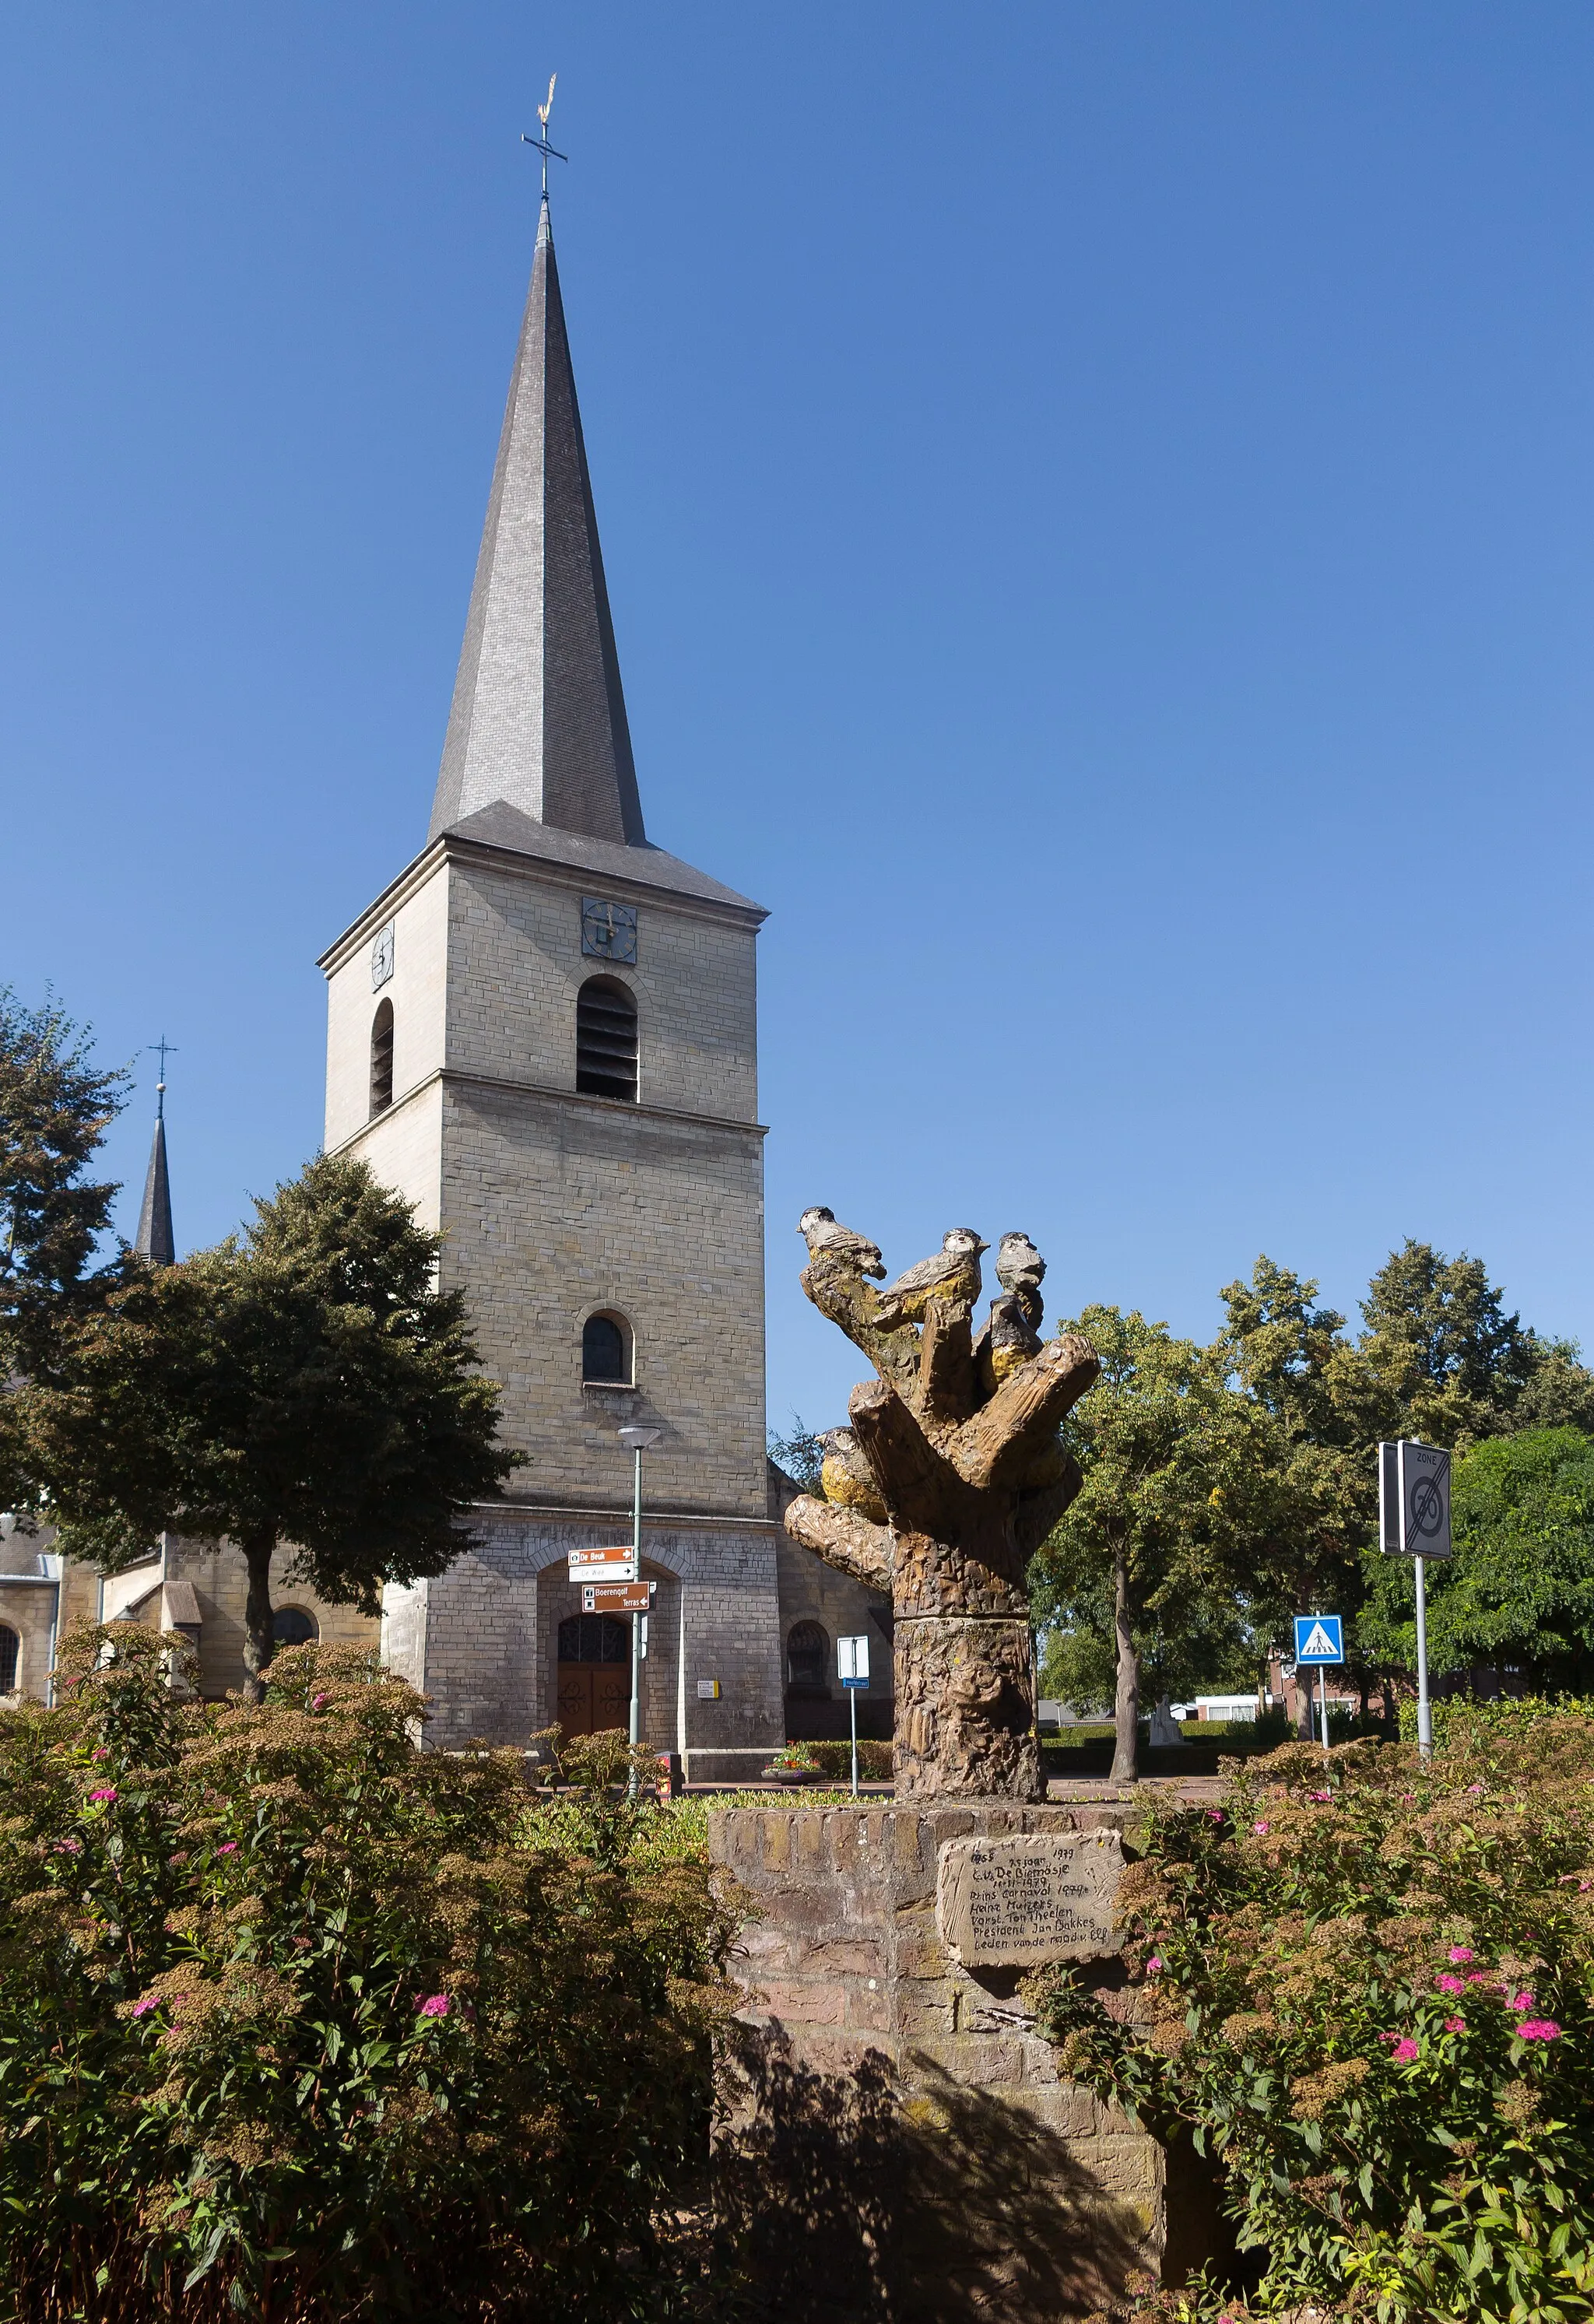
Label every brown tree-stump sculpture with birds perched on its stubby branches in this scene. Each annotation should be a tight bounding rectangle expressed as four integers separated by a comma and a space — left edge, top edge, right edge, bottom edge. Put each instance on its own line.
785, 1209, 1099, 1799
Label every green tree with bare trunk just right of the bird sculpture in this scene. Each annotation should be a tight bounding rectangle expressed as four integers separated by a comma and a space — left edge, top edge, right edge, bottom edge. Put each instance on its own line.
1030, 1306, 1280, 1782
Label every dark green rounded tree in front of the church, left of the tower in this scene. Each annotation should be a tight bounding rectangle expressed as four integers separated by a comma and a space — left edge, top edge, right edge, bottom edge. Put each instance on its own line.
23, 1155, 516, 1699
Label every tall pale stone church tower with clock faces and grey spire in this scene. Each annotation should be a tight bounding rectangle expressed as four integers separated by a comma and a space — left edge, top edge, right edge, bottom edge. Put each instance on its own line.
321, 195, 783, 1773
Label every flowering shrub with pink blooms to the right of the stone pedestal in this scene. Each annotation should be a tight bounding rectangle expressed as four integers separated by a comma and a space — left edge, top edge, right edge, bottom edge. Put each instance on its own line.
1036, 1718, 1594, 2324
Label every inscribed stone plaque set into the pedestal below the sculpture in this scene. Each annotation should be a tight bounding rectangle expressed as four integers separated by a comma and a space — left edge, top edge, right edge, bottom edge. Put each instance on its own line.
936, 1831, 1125, 1968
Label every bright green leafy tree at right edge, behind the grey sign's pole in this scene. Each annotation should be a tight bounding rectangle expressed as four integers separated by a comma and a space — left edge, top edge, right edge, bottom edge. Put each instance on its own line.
1364, 1427, 1594, 1692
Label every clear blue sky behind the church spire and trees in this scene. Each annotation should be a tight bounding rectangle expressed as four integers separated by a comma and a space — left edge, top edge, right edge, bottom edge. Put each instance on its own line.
0, 0, 1594, 1422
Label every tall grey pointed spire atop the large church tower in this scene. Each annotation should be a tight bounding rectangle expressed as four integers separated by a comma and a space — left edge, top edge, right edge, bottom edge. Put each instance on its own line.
427, 195, 646, 846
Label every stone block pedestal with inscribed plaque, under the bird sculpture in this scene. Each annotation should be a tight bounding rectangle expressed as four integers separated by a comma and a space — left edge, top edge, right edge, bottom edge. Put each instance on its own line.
709, 1801, 1167, 2324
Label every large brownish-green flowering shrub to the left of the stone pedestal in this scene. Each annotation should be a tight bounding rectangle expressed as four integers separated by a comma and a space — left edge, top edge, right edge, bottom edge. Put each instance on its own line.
0, 1624, 734, 2324
